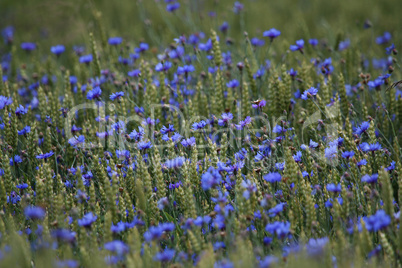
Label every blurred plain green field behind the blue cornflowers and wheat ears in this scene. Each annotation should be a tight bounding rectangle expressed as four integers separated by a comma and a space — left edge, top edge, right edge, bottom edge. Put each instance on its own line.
0, 0, 402, 46
